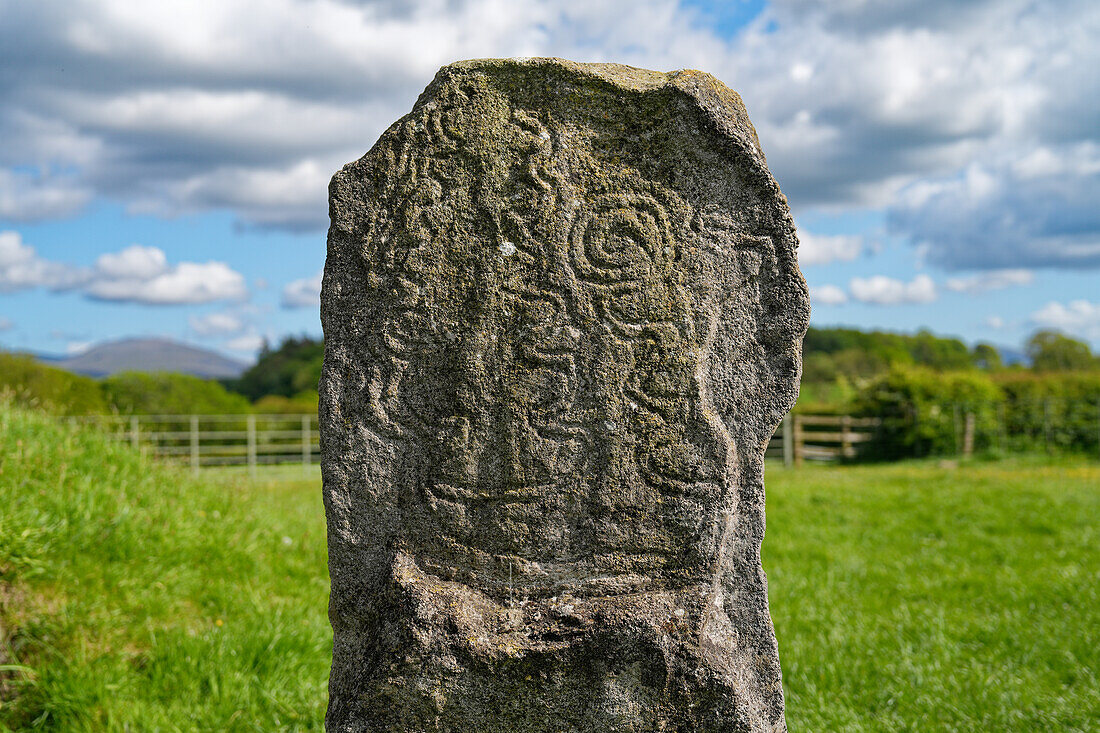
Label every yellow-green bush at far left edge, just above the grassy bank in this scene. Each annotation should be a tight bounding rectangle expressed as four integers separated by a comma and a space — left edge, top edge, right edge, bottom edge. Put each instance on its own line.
0, 353, 107, 415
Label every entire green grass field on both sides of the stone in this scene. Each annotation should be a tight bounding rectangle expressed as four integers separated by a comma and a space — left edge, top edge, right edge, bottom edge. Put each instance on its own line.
0, 406, 1100, 732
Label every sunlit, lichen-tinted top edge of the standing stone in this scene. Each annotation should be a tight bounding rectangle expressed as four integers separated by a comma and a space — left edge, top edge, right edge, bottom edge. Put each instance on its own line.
439, 56, 767, 162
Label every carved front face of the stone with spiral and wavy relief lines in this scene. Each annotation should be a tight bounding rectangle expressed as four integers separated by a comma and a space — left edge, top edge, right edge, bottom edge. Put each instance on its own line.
336, 68, 792, 594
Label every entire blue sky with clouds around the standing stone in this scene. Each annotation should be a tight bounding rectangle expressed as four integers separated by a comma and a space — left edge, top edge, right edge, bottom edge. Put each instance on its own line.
0, 0, 1100, 358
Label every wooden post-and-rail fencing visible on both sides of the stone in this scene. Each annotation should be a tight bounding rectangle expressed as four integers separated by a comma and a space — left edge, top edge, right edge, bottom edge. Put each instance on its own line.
69, 407, 881, 471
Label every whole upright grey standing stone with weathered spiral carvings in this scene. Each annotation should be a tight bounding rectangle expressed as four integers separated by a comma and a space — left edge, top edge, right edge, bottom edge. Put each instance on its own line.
321, 58, 809, 733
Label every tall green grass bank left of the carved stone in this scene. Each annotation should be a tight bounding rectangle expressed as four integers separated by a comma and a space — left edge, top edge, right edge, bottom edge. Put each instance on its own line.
0, 405, 331, 731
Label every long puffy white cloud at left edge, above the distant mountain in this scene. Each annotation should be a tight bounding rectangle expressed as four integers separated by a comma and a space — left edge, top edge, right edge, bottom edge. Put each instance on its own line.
0, 231, 248, 305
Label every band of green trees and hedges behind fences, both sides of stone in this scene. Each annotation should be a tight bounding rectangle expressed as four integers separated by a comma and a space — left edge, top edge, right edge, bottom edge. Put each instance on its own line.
0, 328, 1100, 429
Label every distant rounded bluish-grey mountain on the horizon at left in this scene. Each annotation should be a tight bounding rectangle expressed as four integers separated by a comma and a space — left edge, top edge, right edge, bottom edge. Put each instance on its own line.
39, 339, 250, 379
